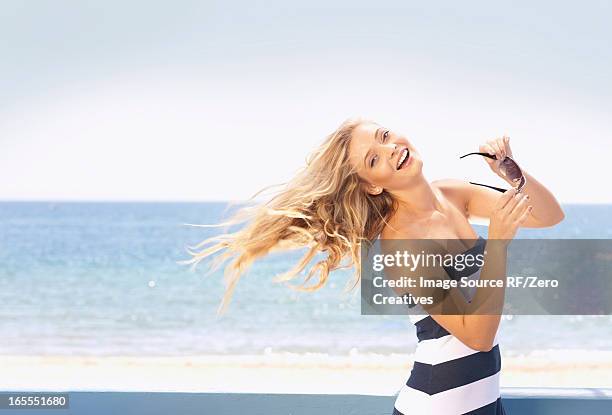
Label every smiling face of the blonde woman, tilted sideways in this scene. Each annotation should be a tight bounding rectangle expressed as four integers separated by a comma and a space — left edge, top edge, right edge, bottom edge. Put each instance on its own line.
349, 123, 423, 194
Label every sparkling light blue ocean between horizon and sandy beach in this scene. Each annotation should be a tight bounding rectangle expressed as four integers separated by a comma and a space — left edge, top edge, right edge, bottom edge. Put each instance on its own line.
0, 202, 612, 356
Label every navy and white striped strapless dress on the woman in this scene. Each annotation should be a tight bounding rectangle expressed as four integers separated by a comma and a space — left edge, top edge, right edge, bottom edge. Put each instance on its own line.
393, 237, 505, 415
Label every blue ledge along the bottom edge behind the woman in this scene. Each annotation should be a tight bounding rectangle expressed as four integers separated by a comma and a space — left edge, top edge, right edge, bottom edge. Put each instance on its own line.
1, 388, 612, 415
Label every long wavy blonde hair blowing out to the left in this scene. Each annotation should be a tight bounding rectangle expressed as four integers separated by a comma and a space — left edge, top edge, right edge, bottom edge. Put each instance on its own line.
182, 118, 397, 314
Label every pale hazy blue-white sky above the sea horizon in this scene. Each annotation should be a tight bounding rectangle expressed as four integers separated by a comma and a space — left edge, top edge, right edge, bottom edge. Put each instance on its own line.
0, 0, 612, 203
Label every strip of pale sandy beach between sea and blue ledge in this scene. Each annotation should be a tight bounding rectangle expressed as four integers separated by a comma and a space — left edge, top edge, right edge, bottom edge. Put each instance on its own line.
0, 350, 612, 395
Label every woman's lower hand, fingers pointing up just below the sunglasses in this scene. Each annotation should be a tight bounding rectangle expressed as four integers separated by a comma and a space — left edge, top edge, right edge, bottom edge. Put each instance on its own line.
489, 189, 533, 243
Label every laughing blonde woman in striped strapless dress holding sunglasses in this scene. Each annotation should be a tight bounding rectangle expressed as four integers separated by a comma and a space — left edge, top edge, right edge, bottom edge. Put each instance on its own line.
189, 119, 564, 414
